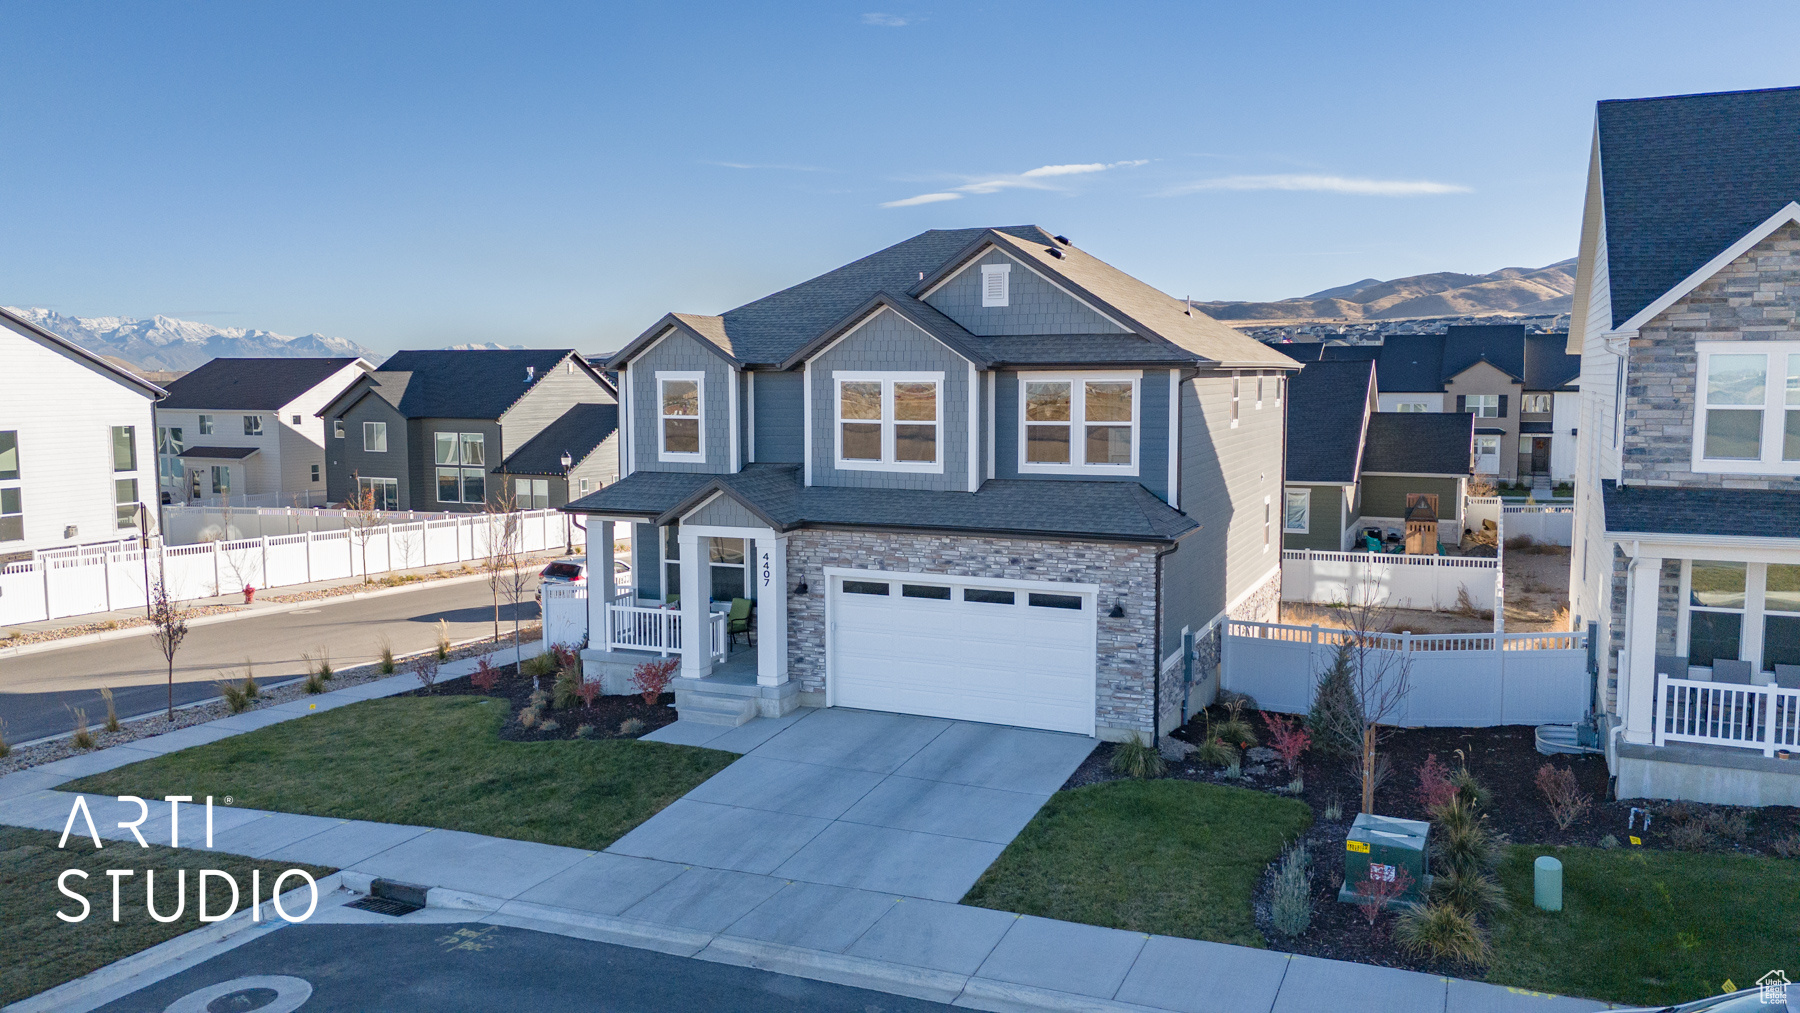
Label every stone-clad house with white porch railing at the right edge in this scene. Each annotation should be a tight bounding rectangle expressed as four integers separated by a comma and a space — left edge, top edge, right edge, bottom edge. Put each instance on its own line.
1568, 88, 1800, 806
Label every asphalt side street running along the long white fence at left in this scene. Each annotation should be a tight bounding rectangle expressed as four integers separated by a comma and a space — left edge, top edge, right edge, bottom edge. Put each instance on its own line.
0, 576, 538, 743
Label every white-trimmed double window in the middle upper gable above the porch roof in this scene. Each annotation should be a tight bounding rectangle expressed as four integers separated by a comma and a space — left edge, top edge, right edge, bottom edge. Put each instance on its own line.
832, 371, 943, 473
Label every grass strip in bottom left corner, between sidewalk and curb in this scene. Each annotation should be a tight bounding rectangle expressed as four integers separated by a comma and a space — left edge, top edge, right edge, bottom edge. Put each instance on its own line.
0, 826, 331, 1006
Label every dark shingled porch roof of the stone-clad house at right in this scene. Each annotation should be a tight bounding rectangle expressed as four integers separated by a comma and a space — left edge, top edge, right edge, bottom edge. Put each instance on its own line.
1600, 479, 1800, 538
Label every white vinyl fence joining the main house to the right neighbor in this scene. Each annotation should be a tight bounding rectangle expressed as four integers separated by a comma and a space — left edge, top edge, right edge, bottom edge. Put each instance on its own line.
1220, 621, 1589, 727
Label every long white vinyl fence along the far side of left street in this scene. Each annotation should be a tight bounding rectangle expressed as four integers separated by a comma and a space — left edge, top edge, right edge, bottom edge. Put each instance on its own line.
0, 509, 583, 626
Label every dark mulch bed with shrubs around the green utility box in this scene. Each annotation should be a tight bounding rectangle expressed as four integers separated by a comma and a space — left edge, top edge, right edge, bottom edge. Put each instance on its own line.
1064, 707, 1800, 979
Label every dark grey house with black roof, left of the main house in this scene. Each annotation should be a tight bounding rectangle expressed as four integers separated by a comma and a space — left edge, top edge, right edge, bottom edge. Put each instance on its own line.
319, 349, 617, 513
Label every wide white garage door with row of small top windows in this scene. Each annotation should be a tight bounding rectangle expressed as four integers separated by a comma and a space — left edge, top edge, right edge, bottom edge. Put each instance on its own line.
828, 572, 1096, 734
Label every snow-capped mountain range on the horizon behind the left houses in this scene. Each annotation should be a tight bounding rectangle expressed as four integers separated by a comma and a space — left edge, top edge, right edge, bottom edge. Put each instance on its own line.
7, 306, 380, 371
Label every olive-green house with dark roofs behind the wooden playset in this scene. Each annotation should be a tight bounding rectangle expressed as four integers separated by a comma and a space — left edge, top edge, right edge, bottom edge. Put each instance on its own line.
1282, 360, 1474, 551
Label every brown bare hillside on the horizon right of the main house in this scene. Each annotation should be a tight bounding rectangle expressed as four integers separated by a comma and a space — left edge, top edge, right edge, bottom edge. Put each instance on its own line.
1195, 257, 1575, 322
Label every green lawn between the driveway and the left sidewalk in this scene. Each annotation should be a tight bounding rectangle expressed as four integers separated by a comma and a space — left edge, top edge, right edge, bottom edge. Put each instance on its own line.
61, 696, 736, 851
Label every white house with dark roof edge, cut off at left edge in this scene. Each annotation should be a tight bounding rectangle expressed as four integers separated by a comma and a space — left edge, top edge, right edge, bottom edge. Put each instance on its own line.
0, 309, 162, 561
